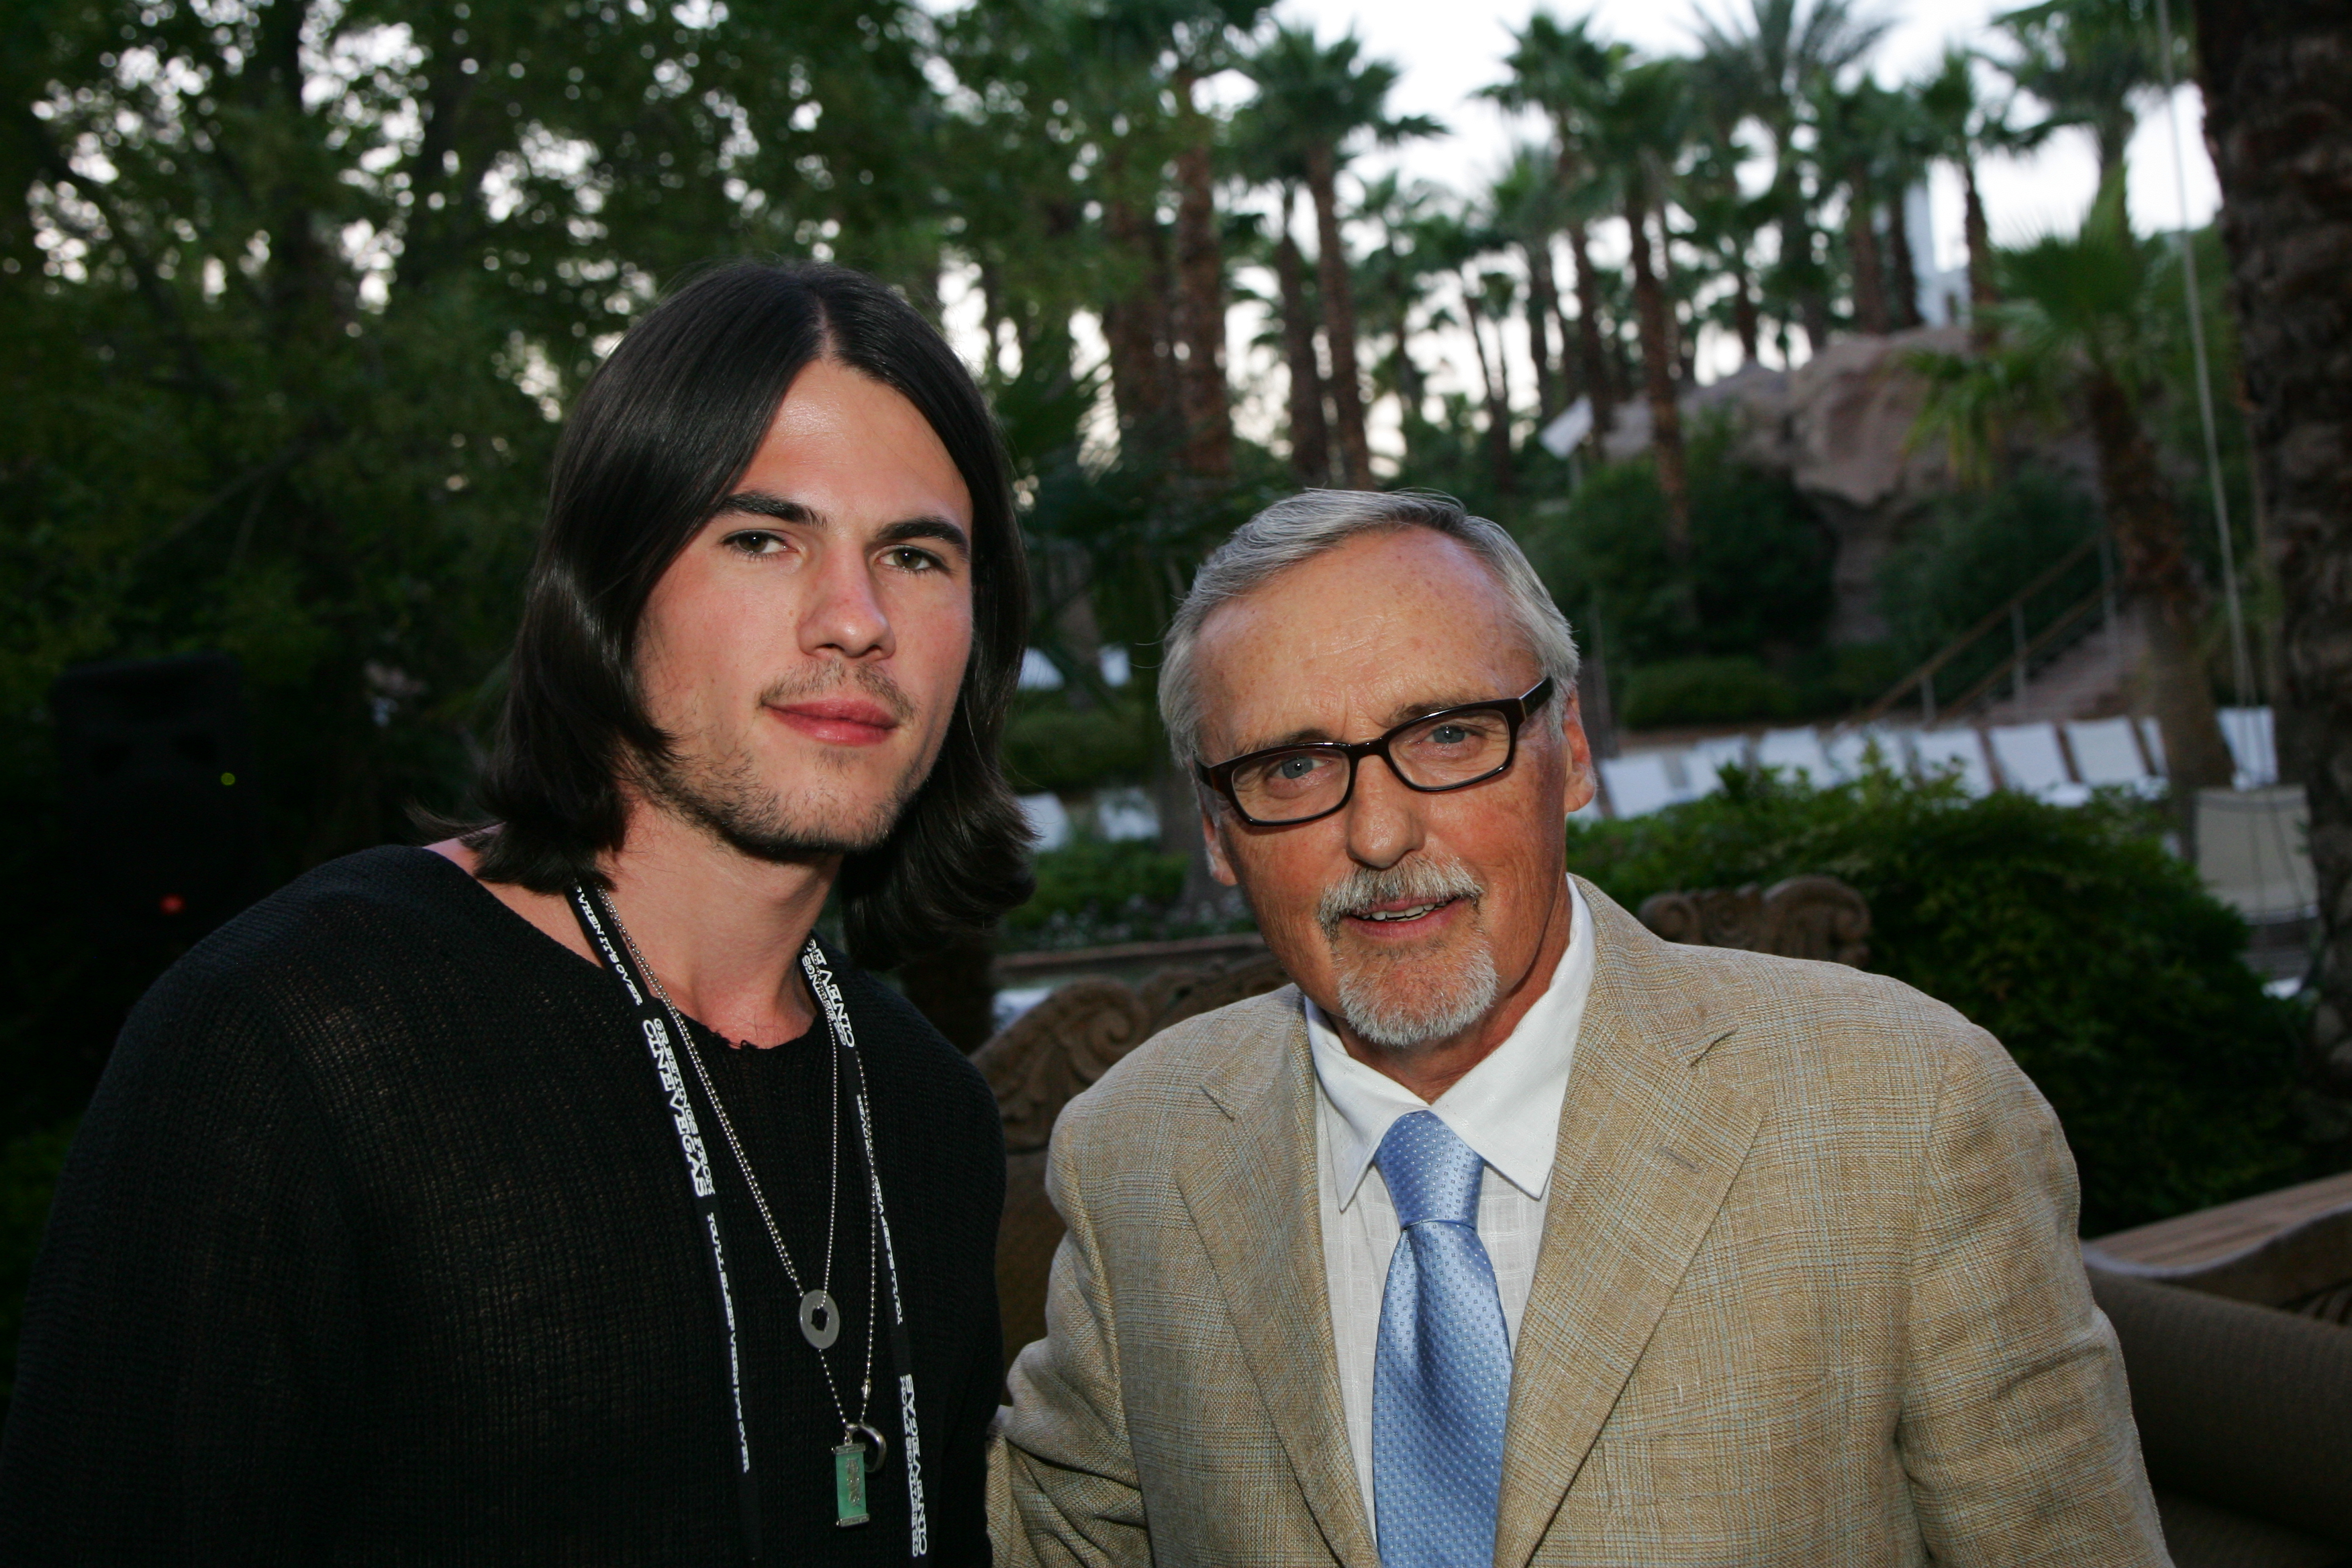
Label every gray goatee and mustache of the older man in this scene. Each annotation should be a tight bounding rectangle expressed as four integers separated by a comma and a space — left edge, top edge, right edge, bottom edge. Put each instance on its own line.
1315, 856, 1503, 1051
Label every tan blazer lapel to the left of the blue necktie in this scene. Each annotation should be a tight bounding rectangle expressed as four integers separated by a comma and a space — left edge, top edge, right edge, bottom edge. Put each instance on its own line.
1176, 987, 1381, 1568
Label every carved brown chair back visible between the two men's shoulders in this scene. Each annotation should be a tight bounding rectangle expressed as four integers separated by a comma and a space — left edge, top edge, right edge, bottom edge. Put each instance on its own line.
971, 954, 1289, 1366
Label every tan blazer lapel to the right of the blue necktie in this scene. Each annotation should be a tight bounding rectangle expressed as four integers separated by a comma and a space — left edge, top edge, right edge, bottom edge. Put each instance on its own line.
1496, 879, 1764, 1568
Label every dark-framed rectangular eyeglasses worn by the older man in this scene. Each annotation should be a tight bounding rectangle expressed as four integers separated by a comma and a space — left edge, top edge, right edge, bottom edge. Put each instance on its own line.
1195, 675, 1553, 828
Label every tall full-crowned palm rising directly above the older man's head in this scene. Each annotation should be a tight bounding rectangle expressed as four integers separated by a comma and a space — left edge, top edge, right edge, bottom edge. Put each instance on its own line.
1244, 26, 1444, 489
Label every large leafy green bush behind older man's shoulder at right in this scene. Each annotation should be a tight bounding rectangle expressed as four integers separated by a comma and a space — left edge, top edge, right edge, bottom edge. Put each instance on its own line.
1569, 771, 2321, 1236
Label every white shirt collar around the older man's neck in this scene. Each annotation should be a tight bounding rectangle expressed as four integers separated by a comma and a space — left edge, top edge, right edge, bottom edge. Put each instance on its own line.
1301, 879, 1592, 1208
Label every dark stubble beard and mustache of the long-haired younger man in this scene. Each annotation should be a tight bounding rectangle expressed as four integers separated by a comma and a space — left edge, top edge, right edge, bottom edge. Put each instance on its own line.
638, 670, 938, 861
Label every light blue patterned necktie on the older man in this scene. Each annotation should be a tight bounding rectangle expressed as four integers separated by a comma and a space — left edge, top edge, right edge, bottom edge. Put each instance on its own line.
1371, 1110, 1510, 1568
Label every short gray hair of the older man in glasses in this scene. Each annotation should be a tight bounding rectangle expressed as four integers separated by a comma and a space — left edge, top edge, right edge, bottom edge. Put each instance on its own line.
1159, 489, 1576, 769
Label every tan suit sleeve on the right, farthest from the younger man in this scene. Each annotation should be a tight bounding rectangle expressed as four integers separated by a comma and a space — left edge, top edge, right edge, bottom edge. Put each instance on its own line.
1896, 1030, 2171, 1568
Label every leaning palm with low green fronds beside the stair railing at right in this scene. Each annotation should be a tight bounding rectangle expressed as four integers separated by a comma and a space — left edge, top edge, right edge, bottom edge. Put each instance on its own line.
1912, 179, 2235, 809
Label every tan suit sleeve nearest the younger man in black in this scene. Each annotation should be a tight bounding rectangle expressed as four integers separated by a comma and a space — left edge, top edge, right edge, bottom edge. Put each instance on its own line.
988, 1105, 1153, 1568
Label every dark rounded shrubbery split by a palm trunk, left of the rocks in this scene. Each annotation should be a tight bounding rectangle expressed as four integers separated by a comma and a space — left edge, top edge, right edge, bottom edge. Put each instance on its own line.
1522, 423, 1834, 665
